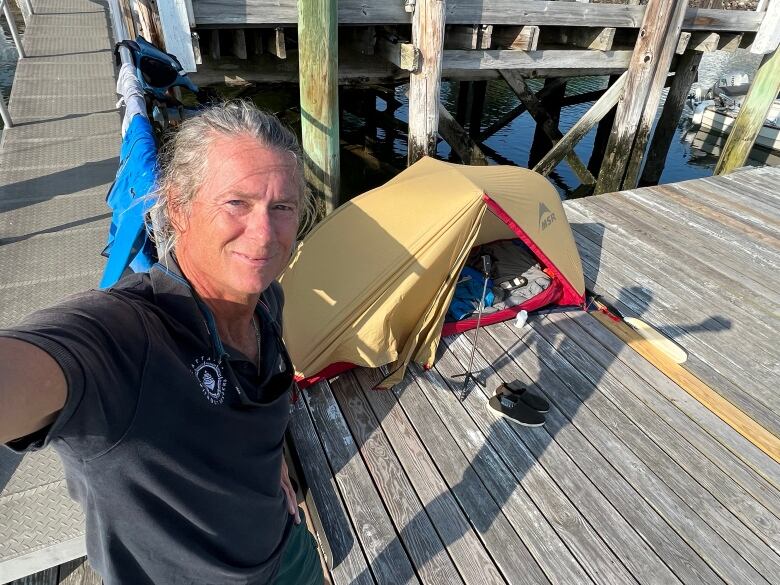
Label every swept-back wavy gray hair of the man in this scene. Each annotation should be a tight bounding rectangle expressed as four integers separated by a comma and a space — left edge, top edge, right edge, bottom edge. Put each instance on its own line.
149, 101, 317, 259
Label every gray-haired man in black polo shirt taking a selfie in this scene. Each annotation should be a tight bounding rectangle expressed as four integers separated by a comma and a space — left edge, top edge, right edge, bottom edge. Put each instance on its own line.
0, 103, 323, 585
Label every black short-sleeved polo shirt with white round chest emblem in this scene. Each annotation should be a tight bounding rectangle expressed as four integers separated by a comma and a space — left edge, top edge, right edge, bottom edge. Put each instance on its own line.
0, 260, 292, 585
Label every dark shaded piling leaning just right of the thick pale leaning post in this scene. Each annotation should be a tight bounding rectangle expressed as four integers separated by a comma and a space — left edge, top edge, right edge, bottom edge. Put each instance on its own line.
640, 49, 702, 185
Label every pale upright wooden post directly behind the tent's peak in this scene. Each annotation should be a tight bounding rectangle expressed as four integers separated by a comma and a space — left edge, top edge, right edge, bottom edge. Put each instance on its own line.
407, 0, 445, 165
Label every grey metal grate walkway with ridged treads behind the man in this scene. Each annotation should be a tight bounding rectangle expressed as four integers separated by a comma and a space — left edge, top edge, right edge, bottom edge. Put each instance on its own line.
0, 0, 120, 583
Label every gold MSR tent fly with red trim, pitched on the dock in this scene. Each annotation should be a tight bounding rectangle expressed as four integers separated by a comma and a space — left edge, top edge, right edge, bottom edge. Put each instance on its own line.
279, 158, 585, 387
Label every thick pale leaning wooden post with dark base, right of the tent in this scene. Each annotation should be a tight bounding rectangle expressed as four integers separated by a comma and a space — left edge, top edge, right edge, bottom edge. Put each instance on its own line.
595, 0, 687, 194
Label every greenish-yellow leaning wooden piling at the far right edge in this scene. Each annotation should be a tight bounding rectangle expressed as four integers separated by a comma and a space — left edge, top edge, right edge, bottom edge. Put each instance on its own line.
715, 49, 780, 175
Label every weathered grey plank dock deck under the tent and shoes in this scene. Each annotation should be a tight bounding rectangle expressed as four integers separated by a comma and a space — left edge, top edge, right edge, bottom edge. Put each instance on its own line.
284, 167, 780, 584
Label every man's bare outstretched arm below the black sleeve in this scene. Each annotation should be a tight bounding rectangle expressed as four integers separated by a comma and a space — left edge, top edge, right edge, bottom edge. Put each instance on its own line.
0, 338, 68, 443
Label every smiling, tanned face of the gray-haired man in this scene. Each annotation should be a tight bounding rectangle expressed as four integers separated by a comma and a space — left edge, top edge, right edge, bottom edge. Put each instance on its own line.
172, 136, 300, 303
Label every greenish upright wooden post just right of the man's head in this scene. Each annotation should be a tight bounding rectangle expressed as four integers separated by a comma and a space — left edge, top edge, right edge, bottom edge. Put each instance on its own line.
298, 0, 341, 213
